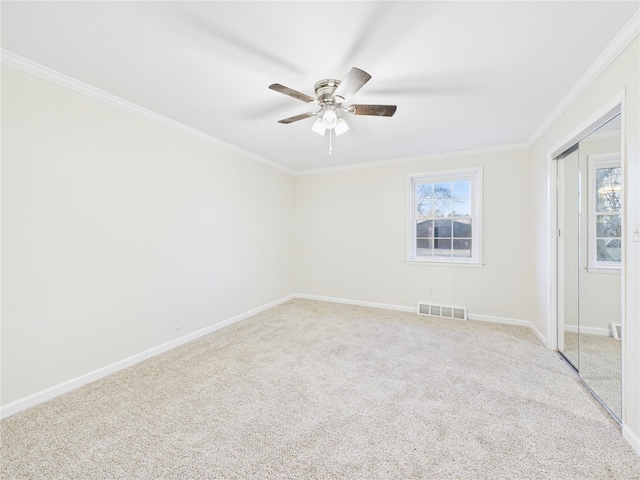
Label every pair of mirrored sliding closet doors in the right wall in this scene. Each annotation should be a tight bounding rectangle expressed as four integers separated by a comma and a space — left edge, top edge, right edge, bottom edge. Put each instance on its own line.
556, 109, 624, 421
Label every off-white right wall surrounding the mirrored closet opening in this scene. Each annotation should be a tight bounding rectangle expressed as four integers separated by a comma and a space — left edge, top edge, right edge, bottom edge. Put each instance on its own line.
531, 37, 640, 452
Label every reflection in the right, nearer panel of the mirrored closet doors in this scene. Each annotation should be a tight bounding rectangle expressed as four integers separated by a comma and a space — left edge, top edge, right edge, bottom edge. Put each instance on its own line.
579, 115, 623, 419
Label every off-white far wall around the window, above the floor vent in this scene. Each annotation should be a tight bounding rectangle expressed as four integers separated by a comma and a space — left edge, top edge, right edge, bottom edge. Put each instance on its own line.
295, 148, 533, 321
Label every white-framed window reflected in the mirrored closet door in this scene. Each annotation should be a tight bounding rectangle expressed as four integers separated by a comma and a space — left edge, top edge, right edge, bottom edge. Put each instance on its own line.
588, 153, 622, 271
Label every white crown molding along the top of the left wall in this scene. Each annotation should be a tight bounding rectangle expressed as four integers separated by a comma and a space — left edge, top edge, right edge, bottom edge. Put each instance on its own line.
0, 49, 294, 175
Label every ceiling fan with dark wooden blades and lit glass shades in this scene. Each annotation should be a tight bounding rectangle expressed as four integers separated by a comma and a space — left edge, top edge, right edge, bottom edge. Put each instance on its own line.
269, 67, 396, 153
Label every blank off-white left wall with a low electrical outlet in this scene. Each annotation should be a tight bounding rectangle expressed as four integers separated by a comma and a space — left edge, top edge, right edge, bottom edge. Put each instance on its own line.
2, 66, 294, 406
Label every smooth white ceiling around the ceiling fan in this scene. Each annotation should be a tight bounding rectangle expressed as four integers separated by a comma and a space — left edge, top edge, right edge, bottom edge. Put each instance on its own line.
1, 1, 639, 171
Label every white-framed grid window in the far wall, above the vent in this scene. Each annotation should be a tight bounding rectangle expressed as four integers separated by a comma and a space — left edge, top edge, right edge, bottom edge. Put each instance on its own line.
408, 168, 482, 264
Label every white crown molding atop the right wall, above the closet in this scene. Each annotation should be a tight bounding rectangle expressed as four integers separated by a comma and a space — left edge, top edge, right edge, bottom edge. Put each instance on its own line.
528, 11, 640, 146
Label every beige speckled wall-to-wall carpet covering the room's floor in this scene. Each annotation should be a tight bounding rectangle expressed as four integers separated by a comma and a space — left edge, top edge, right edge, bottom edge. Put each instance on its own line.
0, 300, 640, 480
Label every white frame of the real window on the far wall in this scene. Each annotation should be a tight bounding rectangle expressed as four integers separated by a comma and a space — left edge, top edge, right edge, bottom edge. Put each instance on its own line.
407, 167, 484, 267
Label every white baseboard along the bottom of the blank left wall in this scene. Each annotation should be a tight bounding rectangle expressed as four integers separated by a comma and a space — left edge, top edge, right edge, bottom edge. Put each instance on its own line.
0, 295, 295, 418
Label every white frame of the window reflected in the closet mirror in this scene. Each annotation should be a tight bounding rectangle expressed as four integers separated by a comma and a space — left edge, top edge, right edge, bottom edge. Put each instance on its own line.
587, 152, 624, 274
